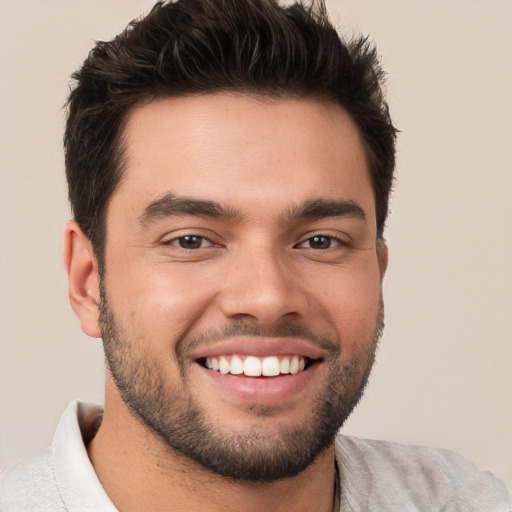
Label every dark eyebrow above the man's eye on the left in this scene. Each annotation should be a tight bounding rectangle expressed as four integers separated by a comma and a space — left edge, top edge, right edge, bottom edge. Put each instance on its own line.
139, 193, 241, 226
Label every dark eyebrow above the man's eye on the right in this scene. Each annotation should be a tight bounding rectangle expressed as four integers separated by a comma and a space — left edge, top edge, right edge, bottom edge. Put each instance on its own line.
282, 198, 366, 224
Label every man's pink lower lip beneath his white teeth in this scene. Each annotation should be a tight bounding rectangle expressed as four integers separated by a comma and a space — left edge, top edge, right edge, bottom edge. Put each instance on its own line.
194, 362, 319, 404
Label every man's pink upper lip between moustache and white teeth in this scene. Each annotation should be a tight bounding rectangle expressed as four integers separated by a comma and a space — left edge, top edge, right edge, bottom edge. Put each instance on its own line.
191, 337, 325, 360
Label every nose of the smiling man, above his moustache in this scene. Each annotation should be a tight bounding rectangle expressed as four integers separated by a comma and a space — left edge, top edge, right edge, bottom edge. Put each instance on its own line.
220, 243, 307, 326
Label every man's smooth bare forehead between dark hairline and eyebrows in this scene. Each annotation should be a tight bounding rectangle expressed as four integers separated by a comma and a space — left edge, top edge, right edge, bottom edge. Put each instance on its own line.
112, 93, 374, 224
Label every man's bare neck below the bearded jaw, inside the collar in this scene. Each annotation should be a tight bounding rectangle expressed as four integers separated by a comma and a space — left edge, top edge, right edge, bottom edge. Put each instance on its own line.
88, 386, 335, 512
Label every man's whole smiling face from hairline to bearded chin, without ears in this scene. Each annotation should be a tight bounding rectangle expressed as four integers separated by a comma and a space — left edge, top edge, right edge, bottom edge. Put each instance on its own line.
100, 94, 385, 481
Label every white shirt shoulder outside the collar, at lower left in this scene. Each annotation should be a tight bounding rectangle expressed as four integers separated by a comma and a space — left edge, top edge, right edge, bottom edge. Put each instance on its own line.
0, 447, 65, 512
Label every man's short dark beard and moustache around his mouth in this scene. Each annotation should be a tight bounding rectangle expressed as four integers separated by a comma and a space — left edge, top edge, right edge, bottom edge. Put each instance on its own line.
100, 290, 384, 483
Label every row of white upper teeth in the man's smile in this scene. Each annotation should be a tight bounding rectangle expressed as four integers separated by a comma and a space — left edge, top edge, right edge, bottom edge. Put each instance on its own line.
206, 355, 306, 377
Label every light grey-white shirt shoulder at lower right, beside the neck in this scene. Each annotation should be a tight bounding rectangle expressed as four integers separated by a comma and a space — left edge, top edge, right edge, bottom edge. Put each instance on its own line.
336, 435, 512, 512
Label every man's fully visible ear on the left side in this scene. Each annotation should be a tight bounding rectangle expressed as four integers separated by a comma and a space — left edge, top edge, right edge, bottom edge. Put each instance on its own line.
63, 220, 101, 338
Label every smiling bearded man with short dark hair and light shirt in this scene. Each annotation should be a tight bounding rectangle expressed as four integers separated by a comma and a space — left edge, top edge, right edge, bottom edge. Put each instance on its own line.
0, 0, 511, 511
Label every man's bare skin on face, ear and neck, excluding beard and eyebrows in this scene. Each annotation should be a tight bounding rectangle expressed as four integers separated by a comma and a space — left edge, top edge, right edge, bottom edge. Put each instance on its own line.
64, 93, 387, 512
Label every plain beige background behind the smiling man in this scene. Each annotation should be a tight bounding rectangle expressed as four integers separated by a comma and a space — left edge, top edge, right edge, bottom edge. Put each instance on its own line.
0, 0, 512, 481
